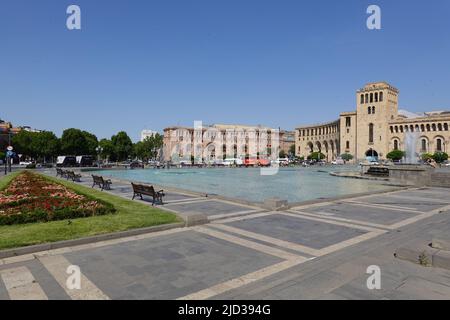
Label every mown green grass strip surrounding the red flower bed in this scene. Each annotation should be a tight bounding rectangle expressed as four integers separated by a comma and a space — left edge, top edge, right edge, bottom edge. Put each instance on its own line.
0, 172, 181, 249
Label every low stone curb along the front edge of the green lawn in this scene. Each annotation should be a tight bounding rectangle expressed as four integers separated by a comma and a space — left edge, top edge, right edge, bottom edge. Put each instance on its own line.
0, 222, 185, 259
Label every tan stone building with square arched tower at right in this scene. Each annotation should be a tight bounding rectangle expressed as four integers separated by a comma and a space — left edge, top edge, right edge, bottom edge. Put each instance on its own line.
295, 82, 450, 161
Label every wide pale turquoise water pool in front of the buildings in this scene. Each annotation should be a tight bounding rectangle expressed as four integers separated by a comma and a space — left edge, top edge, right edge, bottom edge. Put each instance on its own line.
94, 166, 391, 202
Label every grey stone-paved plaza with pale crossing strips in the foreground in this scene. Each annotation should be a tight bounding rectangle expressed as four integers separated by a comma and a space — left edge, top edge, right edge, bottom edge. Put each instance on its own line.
0, 171, 450, 299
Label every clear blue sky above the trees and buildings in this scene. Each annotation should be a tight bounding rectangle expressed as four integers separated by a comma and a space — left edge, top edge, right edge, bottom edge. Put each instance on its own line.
0, 0, 450, 140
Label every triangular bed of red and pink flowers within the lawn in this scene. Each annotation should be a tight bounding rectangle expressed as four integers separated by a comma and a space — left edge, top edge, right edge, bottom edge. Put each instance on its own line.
0, 171, 115, 225
